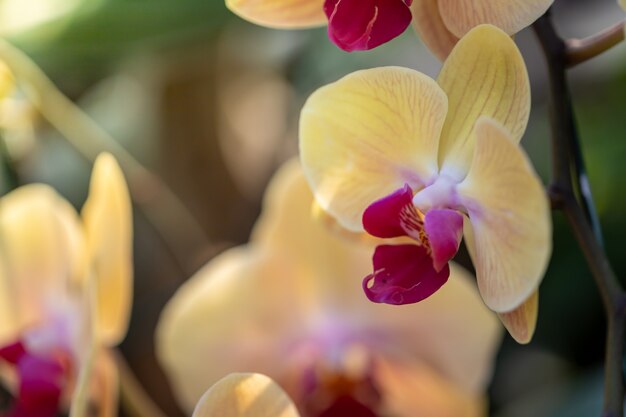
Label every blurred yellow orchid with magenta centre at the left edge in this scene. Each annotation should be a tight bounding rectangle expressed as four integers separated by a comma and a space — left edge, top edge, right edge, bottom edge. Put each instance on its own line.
0, 154, 132, 417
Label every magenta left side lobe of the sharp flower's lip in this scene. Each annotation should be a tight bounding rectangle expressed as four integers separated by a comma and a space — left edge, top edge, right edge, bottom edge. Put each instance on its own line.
363, 184, 422, 240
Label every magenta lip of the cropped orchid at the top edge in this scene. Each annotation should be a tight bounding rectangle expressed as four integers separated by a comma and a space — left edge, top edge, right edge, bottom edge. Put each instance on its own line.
324, 0, 412, 52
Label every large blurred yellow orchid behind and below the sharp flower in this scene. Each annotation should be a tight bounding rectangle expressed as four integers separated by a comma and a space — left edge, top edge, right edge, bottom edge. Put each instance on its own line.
156, 161, 501, 417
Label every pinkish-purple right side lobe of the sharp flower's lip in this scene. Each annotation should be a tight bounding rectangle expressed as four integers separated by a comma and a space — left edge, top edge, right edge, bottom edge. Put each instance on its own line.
424, 209, 463, 271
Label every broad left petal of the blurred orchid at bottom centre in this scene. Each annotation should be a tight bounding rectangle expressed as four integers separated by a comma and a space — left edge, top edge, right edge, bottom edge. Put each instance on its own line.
156, 248, 307, 411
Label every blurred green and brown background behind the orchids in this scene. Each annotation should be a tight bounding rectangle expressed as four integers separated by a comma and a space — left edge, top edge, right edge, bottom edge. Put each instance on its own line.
0, 0, 626, 417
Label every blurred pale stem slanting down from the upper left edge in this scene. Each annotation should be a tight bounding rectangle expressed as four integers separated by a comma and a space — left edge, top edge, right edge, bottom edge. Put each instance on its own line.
0, 38, 209, 275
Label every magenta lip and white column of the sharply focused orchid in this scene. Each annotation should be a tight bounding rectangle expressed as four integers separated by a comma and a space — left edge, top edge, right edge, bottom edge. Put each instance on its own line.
363, 179, 463, 304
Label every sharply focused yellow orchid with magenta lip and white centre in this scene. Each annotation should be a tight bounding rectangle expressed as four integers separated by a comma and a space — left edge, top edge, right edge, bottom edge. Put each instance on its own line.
300, 25, 551, 342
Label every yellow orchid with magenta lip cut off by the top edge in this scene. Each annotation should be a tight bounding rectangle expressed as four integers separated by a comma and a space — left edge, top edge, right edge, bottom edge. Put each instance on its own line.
226, 0, 554, 52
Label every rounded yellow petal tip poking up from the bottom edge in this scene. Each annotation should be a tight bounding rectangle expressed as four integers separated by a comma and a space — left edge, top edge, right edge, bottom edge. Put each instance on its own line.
192, 373, 299, 417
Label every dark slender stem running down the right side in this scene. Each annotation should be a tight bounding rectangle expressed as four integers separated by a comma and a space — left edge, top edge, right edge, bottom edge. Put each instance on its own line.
533, 13, 626, 417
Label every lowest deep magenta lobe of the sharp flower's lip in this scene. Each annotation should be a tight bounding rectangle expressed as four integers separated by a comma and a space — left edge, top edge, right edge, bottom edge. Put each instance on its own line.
363, 245, 450, 305
